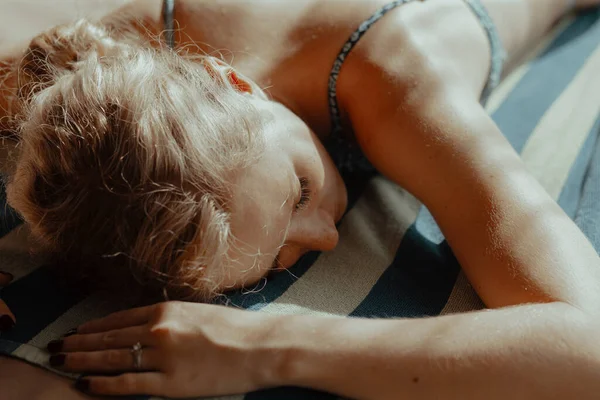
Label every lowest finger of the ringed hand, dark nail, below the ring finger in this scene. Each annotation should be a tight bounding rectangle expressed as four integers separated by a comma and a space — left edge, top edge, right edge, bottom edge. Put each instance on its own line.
75, 372, 168, 396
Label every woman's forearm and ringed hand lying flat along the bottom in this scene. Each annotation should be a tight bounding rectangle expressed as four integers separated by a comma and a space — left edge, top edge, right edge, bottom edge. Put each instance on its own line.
48, 302, 600, 400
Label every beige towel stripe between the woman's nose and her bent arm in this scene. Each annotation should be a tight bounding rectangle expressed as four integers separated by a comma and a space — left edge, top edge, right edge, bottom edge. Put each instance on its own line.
262, 178, 420, 315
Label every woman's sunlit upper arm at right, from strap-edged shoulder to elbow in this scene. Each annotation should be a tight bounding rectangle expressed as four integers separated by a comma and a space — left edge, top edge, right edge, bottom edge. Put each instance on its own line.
338, 0, 600, 313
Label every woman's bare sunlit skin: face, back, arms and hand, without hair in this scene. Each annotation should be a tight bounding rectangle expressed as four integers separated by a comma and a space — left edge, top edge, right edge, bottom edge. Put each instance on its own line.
0, 0, 600, 400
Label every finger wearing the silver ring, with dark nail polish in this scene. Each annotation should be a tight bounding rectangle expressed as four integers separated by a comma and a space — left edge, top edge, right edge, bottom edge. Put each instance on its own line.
49, 348, 160, 373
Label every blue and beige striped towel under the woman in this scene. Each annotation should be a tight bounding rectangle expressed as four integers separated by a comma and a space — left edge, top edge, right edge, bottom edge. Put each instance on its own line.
0, 11, 600, 400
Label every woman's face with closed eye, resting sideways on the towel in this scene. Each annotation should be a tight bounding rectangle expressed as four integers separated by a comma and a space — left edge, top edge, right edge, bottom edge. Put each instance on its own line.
214, 100, 347, 290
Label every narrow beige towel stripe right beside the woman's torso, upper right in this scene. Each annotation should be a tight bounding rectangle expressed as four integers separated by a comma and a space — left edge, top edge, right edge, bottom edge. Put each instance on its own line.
486, 16, 575, 114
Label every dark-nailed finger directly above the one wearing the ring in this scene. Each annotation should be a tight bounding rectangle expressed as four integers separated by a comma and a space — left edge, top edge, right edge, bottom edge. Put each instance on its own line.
48, 325, 154, 353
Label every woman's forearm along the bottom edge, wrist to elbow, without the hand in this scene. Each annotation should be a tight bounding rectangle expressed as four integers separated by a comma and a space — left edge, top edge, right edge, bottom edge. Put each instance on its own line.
265, 303, 600, 400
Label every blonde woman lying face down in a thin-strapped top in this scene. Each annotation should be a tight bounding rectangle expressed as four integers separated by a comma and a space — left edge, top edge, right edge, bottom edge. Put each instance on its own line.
1, 0, 600, 398
